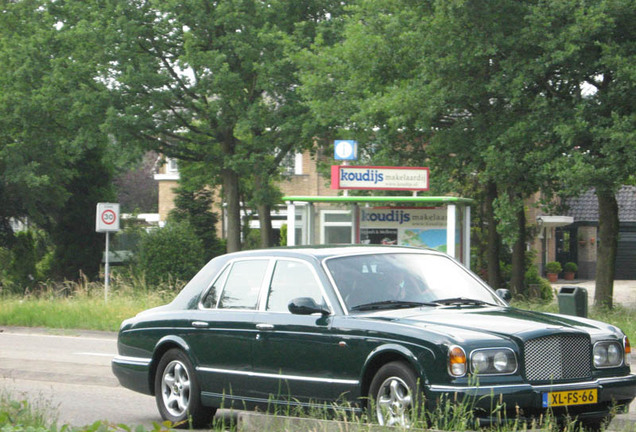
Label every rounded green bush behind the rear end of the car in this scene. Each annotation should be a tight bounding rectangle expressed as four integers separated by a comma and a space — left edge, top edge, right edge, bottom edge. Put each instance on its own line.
136, 221, 206, 285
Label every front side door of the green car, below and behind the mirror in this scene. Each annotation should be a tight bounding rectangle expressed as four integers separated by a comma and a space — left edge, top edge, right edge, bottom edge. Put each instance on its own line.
252, 259, 358, 403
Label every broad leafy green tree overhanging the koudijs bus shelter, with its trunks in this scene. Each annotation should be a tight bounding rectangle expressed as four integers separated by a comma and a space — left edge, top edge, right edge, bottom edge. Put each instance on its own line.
302, 0, 545, 292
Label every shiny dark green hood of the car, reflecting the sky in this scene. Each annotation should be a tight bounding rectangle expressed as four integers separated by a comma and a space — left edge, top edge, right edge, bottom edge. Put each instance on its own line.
366, 306, 622, 339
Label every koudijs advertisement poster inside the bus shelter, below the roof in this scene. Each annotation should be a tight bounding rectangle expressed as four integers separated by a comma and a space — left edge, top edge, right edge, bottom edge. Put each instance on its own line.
360, 207, 447, 252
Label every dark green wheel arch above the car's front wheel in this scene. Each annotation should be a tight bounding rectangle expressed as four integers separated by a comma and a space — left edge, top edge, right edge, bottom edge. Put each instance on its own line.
360, 344, 426, 398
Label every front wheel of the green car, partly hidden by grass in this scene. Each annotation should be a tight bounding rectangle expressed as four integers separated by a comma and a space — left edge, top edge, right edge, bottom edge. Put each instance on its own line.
367, 361, 424, 427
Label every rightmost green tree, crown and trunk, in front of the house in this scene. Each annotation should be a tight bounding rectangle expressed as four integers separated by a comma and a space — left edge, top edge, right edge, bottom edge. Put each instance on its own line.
532, 0, 636, 307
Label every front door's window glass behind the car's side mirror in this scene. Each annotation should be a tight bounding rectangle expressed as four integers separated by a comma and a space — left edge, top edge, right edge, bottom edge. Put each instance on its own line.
266, 260, 324, 313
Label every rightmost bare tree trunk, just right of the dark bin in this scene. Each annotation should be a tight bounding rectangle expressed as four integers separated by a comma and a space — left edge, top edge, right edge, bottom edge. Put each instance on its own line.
594, 189, 619, 308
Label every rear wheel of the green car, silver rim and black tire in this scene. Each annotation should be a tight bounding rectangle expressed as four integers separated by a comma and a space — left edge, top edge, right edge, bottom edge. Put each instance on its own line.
155, 348, 216, 428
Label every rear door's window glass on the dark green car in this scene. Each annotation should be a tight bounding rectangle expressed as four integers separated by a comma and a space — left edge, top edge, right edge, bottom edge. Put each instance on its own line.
219, 259, 269, 309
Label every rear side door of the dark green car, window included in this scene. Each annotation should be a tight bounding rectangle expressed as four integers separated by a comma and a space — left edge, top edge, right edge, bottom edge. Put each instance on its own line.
190, 258, 270, 408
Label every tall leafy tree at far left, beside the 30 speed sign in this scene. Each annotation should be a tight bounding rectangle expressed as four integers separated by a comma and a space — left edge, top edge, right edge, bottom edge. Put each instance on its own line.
0, 0, 118, 278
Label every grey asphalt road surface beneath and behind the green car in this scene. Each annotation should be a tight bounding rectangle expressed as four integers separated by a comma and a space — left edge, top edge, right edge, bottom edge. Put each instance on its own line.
0, 328, 636, 431
